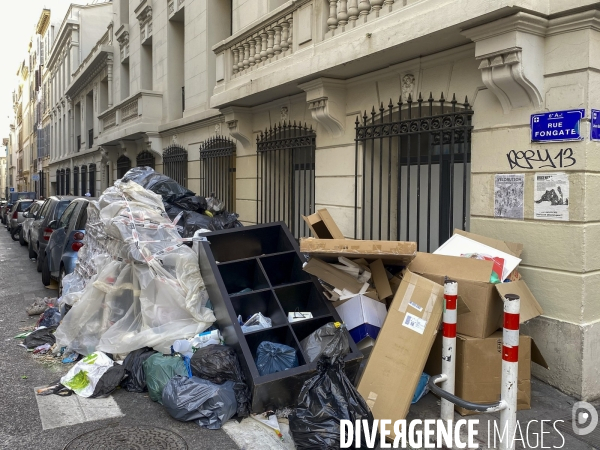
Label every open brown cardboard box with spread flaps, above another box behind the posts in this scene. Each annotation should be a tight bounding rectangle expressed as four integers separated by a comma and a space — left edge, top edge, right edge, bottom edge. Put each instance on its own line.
408, 253, 542, 338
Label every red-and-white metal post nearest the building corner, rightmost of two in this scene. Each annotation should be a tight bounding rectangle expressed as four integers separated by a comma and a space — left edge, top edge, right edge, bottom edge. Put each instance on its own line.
500, 294, 521, 450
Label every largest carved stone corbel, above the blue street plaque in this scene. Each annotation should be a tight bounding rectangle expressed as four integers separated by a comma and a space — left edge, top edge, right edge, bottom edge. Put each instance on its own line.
462, 13, 548, 114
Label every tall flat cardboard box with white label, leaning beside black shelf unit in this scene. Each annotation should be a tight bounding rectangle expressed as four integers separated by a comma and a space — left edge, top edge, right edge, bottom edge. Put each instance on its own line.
358, 270, 444, 439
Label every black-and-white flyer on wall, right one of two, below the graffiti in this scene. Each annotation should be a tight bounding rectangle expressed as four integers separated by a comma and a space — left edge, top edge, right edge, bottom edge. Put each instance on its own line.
533, 172, 569, 220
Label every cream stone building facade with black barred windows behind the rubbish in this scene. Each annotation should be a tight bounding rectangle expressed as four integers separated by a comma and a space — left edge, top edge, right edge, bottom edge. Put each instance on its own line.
30, 0, 600, 399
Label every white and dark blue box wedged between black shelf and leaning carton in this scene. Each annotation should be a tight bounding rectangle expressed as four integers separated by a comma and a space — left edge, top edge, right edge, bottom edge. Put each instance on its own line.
335, 295, 387, 356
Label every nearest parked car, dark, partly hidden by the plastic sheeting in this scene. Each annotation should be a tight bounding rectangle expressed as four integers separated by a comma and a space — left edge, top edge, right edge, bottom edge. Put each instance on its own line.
42, 197, 94, 296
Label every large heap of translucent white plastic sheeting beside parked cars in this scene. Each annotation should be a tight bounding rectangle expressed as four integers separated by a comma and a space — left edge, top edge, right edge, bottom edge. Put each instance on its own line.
55, 176, 215, 355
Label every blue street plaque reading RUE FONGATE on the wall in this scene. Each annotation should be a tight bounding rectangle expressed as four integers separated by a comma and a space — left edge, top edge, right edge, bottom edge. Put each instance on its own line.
531, 109, 585, 142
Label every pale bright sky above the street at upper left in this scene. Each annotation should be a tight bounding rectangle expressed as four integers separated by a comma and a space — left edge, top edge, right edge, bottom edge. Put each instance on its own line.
0, 0, 74, 138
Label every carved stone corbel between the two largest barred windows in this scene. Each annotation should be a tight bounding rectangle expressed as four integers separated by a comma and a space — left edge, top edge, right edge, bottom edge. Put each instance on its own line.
298, 78, 346, 137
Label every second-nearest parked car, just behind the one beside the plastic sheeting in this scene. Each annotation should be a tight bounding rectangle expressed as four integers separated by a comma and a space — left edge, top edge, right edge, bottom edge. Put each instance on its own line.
28, 195, 77, 272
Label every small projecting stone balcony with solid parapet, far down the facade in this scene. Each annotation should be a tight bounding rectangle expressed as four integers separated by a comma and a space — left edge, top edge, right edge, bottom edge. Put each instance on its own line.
97, 90, 163, 145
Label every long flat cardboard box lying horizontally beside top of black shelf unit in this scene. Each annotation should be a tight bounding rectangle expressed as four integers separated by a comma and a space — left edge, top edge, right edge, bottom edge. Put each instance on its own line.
300, 238, 417, 266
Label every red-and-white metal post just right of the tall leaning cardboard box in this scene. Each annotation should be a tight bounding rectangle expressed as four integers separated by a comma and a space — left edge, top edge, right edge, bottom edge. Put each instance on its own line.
441, 280, 458, 420
